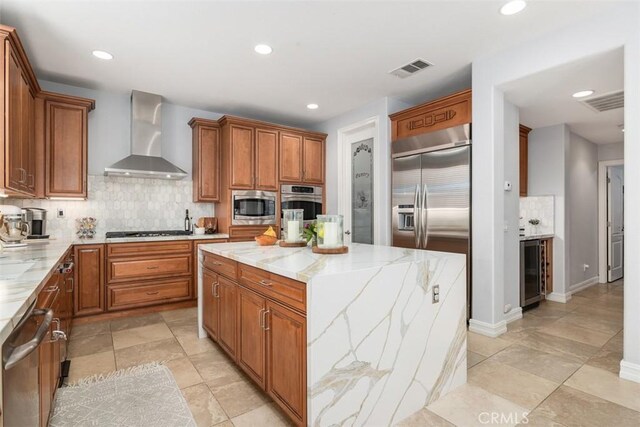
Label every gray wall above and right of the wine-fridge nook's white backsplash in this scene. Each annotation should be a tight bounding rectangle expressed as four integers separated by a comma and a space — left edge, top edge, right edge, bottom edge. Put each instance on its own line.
528, 124, 570, 294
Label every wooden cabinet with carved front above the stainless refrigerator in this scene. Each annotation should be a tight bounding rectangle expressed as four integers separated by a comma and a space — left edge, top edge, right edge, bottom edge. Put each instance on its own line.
389, 89, 471, 141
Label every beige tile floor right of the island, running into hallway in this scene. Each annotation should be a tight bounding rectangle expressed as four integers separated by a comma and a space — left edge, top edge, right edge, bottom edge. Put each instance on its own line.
402, 281, 640, 427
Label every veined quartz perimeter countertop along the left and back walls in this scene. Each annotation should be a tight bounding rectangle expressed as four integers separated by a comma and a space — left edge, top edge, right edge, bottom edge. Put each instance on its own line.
0, 234, 229, 344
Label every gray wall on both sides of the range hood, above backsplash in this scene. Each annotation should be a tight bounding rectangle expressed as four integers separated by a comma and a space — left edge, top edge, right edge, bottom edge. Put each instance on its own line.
40, 80, 223, 180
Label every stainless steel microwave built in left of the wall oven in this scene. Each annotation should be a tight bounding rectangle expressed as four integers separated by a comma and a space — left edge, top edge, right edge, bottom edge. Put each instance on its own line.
231, 190, 277, 225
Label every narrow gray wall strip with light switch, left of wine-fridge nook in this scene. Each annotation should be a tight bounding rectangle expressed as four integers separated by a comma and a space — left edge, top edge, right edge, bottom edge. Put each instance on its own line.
504, 101, 520, 311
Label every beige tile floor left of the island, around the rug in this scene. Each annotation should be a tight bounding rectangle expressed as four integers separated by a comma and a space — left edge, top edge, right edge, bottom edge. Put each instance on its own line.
67, 308, 291, 427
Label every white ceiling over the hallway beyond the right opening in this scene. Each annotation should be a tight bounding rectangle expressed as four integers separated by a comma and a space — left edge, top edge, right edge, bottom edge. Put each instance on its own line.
501, 48, 624, 144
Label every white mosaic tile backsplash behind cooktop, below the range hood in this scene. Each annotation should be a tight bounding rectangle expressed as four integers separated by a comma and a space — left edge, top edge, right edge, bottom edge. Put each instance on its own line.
0, 175, 214, 238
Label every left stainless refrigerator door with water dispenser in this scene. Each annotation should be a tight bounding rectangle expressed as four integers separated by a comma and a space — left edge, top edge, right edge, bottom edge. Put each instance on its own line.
391, 154, 422, 248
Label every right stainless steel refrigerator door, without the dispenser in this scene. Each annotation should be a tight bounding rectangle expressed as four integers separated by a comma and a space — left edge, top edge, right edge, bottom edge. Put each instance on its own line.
420, 146, 471, 254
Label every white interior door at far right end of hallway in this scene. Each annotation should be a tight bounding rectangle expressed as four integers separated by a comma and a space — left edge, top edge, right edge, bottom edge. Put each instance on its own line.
607, 166, 624, 282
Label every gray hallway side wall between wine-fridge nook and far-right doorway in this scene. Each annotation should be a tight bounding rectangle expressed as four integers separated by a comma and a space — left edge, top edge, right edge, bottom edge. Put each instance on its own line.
567, 133, 598, 287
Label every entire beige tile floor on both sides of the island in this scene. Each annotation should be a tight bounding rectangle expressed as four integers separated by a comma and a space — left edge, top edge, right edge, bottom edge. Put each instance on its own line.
69, 281, 640, 427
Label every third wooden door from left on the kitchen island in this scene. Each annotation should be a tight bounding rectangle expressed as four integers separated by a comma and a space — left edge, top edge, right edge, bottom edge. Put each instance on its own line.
238, 286, 266, 389
